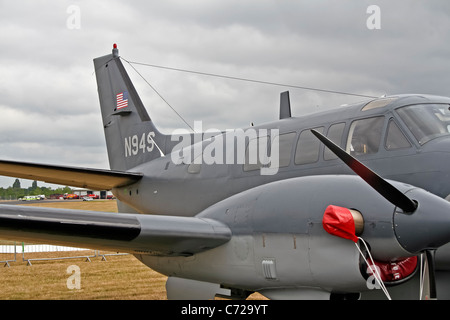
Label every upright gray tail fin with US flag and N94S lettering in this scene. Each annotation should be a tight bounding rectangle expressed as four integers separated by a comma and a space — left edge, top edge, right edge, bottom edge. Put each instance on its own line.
94, 45, 166, 171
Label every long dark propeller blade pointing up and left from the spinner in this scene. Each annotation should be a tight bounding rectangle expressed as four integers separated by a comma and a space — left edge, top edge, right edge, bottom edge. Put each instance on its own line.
311, 130, 417, 213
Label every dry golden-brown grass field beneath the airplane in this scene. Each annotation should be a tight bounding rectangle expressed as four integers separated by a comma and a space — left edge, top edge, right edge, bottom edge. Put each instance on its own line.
0, 200, 263, 300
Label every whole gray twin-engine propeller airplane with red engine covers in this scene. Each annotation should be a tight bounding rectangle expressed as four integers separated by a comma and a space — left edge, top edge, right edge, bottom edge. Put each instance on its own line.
0, 46, 450, 299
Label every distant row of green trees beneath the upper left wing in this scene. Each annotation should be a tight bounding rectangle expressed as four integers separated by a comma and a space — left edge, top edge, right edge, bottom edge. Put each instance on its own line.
0, 179, 72, 200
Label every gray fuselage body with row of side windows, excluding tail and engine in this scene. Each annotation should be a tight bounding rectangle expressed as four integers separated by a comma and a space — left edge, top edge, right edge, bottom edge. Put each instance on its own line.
114, 96, 450, 216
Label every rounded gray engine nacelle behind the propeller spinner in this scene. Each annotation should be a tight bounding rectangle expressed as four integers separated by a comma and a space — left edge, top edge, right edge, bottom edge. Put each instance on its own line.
198, 176, 418, 292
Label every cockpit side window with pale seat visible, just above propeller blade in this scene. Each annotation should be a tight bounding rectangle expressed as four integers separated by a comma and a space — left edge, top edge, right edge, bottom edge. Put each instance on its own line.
346, 116, 384, 156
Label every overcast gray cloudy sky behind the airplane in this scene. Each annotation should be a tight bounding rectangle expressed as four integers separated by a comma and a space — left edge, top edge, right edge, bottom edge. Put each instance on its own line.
0, 0, 450, 186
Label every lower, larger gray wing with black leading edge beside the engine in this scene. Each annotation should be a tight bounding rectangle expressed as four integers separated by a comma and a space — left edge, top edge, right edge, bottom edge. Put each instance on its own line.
0, 205, 231, 256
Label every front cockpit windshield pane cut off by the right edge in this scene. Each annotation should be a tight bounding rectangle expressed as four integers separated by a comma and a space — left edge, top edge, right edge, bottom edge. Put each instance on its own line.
397, 104, 450, 145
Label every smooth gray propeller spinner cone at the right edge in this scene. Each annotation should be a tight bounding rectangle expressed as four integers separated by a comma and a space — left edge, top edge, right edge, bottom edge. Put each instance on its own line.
394, 188, 450, 253
